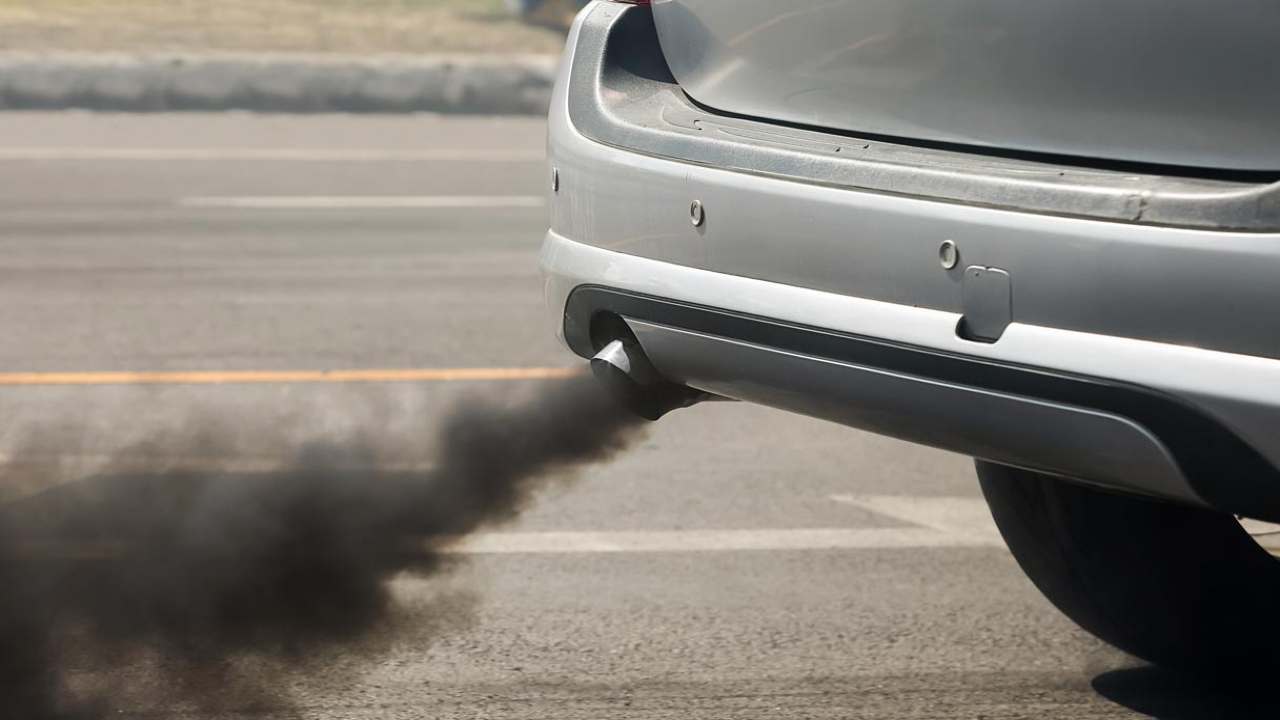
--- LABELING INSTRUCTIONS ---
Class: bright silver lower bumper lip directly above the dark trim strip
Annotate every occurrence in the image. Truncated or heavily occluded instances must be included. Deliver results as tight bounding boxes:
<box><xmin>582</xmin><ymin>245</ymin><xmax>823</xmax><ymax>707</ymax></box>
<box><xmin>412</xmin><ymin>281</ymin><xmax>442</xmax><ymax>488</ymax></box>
<box><xmin>540</xmin><ymin>232</ymin><xmax>1280</xmax><ymax>476</ymax></box>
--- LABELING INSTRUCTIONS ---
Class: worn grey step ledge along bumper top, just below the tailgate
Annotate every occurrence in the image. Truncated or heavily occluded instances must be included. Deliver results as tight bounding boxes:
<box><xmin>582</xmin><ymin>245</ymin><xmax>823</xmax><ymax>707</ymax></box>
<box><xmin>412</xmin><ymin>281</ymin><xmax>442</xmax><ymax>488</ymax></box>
<box><xmin>562</xmin><ymin>3</ymin><xmax>1280</xmax><ymax>232</ymax></box>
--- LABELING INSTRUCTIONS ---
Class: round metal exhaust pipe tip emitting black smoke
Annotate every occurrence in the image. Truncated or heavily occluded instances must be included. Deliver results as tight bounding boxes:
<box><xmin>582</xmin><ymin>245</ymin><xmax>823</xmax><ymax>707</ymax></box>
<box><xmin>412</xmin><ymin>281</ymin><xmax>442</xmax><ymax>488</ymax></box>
<box><xmin>591</xmin><ymin>340</ymin><xmax>713</xmax><ymax>420</ymax></box>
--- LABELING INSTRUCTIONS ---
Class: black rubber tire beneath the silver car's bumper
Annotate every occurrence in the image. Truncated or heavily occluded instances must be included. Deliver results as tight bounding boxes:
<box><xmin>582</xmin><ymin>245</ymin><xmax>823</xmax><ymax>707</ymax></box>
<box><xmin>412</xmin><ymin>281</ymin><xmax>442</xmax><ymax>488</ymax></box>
<box><xmin>977</xmin><ymin>460</ymin><xmax>1280</xmax><ymax>676</ymax></box>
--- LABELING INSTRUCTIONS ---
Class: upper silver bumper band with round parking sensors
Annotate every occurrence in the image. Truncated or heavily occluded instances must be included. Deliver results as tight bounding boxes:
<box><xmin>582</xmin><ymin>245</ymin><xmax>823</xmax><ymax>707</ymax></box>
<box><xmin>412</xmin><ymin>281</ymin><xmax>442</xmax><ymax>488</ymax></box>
<box><xmin>548</xmin><ymin>5</ymin><xmax>1280</xmax><ymax>357</ymax></box>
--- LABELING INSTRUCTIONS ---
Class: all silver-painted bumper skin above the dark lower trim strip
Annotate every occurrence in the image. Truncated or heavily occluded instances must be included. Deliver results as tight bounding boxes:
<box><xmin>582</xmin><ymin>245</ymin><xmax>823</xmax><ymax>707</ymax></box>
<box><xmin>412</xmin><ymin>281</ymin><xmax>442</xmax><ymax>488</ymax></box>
<box><xmin>541</xmin><ymin>6</ymin><xmax>1280</xmax><ymax>497</ymax></box>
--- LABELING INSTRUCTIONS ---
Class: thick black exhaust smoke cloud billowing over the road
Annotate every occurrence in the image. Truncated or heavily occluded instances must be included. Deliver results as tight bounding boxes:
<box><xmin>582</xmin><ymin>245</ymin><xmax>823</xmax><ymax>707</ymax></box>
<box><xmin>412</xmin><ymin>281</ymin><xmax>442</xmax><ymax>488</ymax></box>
<box><xmin>0</xmin><ymin>377</ymin><xmax>639</xmax><ymax>720</ymax></box>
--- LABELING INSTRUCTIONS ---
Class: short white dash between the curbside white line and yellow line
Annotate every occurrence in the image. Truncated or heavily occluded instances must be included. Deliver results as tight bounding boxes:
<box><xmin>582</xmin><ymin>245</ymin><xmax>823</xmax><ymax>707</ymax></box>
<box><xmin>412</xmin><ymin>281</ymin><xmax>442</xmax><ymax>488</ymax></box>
<box><xmin>178</xmin><ymin>195</ymin><xmax>547</xmax><ymax>210</ymax></box>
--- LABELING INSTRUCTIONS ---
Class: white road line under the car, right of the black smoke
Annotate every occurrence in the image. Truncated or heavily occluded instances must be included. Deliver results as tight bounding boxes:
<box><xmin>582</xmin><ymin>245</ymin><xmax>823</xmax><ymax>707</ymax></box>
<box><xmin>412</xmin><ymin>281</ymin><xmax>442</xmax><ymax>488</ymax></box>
<box><xmin>440</xmin><ymin>528</ymin><xmax>988</xmax><ymax>555</ymax></box>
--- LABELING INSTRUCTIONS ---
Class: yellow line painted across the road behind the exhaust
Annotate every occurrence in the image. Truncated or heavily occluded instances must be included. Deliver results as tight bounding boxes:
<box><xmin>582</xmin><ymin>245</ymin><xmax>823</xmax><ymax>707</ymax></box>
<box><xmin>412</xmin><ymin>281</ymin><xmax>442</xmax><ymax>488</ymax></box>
<box><xmin>0</xmin><ymin>368</ymin><xmax>582</xmax><ymax>386</ymax></box>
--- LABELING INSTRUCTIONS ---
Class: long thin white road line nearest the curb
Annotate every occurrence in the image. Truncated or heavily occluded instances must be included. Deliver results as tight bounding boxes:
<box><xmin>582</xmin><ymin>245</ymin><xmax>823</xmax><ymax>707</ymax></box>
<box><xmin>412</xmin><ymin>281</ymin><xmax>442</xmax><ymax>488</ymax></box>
<box><xmin>0</xmin><ymin>147</ymin><xmax>545</xmax><ymax>163</ymax></box>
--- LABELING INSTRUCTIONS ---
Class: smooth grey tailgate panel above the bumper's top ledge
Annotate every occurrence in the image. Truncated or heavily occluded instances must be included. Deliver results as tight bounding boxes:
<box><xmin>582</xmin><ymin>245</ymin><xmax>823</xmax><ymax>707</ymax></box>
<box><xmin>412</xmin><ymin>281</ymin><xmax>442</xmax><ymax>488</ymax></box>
<box><xmin>653</xmin><ymin>0</ymin><xmax>1280</xmax><ymax>172</ymax></box>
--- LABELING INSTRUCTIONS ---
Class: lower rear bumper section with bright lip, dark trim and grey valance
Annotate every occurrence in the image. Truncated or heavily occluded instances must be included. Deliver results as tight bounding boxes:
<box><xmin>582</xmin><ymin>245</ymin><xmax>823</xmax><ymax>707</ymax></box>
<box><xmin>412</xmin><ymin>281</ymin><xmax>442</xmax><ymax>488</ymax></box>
<box><xmin>541</xmin><ymin>232</ymin><xmax>1280</xmax><ymax>519</ymax></box>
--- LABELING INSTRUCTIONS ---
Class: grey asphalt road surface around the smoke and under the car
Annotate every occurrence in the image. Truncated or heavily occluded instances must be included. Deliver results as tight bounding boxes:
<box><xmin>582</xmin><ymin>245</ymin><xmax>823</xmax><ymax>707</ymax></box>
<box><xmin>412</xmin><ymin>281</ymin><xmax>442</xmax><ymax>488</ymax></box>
<box><xmin>0</xmin><ymin>114</ymin><xmax>1225</xmax><ymax>719</ymax></box>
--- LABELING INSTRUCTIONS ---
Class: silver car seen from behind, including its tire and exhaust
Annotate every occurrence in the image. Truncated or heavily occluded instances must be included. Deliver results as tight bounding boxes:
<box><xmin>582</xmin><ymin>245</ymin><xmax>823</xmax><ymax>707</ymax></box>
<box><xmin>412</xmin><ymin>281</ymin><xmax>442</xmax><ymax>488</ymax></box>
<box><xmin>541</xmin><ymin>0</ymin><xmax>1280</xmax><ymax>669</ymax></box>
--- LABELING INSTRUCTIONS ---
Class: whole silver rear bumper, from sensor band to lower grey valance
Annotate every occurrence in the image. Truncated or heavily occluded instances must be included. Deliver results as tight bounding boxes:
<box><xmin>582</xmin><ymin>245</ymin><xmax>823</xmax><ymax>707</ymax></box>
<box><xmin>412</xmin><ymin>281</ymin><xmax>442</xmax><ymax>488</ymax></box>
<box><xmin>541</xmin><ymin>1</ymin><xmax>1280</xmax><ymax>518</ymax></box>
